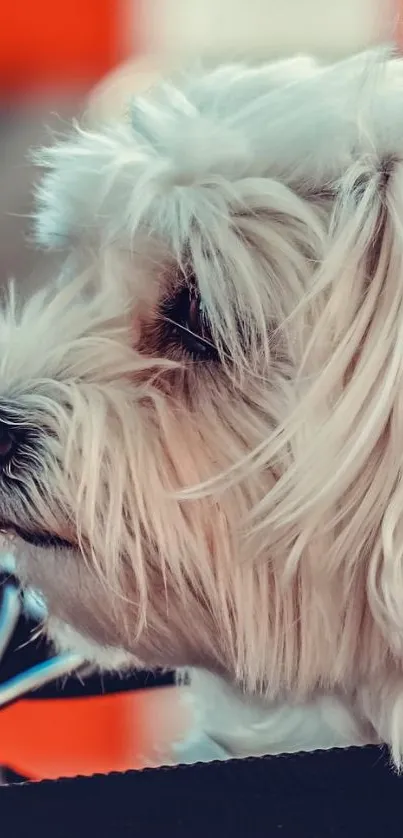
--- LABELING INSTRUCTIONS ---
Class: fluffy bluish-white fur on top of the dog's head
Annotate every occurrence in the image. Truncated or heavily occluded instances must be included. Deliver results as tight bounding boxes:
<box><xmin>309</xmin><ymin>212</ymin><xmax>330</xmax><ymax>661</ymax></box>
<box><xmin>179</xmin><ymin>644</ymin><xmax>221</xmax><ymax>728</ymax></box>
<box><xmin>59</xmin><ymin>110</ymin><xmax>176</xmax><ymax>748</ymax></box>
<box><xmin>35</xmin><ymin>51</ymin><xmax>403</xmax><ymax>251</ymax></box>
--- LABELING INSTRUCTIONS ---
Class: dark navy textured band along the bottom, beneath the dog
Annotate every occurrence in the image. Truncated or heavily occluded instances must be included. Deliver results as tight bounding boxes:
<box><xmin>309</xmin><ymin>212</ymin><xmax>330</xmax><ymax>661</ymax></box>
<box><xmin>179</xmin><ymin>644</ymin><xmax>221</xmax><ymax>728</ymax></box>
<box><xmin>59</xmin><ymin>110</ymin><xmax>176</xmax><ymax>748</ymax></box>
<box><xmin>0</xmin><ymin>747</ymin><xmax>403</xmax><ymax>838</ymax></box>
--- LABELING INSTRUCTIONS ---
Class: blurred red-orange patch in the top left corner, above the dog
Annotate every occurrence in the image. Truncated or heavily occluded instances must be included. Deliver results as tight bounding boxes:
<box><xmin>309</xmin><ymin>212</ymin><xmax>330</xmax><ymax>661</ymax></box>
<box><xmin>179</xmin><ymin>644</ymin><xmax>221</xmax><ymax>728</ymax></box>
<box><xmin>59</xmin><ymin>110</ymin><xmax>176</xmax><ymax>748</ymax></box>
<box><xmin>0</xmin><ymin>0</ymin><xmax>137</xmax><ymax>95</ymax></box>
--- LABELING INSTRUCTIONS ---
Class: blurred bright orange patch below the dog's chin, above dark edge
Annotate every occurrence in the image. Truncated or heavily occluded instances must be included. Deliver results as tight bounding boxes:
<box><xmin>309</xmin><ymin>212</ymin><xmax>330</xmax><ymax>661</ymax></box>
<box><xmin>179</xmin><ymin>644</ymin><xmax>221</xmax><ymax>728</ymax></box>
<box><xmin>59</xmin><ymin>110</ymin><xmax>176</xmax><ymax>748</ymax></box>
<box><xmin>0</xmin><ymin>687</ymin><xmax>185</xmax><ymax>782</ymax></box>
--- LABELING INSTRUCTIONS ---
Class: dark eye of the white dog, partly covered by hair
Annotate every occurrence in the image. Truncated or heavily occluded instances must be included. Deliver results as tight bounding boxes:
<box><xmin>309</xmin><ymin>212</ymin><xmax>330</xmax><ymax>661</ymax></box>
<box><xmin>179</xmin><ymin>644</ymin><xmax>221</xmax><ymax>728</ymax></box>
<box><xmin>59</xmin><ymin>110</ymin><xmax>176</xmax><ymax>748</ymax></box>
<box><xmin>163</xmin><ymin>285</ymin><xmax>218</xmax><ymax>361</ymax></box>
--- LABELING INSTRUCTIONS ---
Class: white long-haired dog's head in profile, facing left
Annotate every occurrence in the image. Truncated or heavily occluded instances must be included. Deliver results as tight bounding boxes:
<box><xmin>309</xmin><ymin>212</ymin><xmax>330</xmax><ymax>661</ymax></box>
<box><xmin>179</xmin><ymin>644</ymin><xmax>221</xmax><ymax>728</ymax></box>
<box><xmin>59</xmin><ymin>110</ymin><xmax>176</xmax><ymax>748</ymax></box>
<box><xmin>0</xmin><ymin>47</ymin><xmax>403</xmax><ymax>765</ymax></box>
